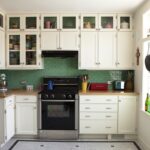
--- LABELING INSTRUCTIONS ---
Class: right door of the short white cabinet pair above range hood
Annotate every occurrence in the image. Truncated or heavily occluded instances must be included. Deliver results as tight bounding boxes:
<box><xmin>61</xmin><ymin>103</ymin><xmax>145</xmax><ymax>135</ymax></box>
<box><xmin>60</xmin><ymin>32</ymin><xmax>79</xmax><ymax>50</ymax></box>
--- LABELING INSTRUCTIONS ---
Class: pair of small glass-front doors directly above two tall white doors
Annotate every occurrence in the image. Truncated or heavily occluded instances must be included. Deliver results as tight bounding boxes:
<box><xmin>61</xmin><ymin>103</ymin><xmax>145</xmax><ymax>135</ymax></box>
<box><xmin>81</xmin><ymin>14</ymin><xmax>116</xmax><ymax>31</ymax></box>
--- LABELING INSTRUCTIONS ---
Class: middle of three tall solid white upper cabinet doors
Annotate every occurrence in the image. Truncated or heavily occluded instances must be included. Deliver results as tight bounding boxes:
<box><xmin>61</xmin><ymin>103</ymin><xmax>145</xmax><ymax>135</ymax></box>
<box><xmin>99</xmin><ymin>32</ymin><xmax>116</xmax><ymax>69</ymax></box>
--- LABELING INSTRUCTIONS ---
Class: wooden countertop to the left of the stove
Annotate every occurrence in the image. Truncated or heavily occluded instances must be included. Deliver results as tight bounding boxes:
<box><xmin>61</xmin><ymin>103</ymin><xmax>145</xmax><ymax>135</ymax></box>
<box><xmin>0</xmin><ymin>89</ymin><xmax>38</xmax><ymax>99</ymax></box>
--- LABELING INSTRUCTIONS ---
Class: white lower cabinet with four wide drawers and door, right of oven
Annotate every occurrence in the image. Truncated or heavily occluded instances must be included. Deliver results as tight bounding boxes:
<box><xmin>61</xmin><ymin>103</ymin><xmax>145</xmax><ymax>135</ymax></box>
<box><xmin>79</xmin><ymin>95</ymin><xmax>137</xmax><ymax>134</ymax></box>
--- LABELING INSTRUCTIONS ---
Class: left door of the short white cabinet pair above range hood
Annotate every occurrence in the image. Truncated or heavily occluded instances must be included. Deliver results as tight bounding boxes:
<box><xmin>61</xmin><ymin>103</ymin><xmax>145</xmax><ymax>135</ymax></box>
<box><xmin>41</xmin><ymin>32</ymin><xmax>59</xmax><ymax>50</ymax></box>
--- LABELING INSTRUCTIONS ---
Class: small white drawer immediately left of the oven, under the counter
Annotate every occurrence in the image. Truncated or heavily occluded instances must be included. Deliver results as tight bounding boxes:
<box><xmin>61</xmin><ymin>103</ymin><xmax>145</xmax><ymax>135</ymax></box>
<box><xmin>16</xmin><ymin>95</ymin><xmax>37</xmax><ymax>103</ymax></box>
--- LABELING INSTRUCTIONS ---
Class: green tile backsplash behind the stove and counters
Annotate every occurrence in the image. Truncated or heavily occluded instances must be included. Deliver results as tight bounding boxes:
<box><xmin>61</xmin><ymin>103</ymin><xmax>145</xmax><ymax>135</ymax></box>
<box><xmin>0</xmin><ymin>57</ymin><xmax>133</xmax><ymax>89</ymax></box>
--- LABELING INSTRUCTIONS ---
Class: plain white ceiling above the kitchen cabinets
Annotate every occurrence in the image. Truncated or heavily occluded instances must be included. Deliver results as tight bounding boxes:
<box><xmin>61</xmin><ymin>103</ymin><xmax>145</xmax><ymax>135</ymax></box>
<box><xmin>0</xmin><ymin>0</ymin><xmax>146</xmax><ymax>12</ymax></box>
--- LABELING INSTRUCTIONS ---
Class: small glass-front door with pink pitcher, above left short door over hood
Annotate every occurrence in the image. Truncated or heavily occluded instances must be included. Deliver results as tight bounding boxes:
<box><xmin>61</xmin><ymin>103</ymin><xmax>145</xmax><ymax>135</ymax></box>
<box><xmin>41</xmin><ymin>14</ymin><xmax>59</xmax><ymax>31</ymax></box>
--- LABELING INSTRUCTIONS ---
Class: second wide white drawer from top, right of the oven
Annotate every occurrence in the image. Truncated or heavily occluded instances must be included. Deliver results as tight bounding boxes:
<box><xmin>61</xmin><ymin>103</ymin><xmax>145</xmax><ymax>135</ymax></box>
<box><xmin>80</xmin><ymin>104</ymin><xmax>117</xmax><ymax>112</ymax></box>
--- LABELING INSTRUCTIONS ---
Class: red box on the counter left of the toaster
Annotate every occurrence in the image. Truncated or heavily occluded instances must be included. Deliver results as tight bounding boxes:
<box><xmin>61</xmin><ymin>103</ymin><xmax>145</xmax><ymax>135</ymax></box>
<box><xmin>90</xmin><ymin>83</ymin><xmax>108</xmax><ymax>91</ymax></box>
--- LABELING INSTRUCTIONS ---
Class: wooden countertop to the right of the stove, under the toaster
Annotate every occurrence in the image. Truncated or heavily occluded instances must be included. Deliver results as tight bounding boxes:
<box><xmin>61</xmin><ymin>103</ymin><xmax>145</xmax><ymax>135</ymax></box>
<box><xmin>79</xmin><ymin>91</ymin><xmax>139</xmax><ymax>96</ymax></box>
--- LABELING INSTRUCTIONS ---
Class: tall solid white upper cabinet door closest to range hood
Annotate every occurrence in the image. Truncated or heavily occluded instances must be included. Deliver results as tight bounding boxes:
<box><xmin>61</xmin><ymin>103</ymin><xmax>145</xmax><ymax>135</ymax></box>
<box><xmin>80</xmin><ymin>32</ymin><xmax>98</xmax><ymax>69</ymax></box>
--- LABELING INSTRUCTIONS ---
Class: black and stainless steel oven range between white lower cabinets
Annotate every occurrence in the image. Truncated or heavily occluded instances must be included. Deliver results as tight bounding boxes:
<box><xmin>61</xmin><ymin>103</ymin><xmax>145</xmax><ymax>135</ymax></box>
<box><xmin>38</xmin><ymin>78</ymin><xmax>79</xmax><ymax>139</ymax></box>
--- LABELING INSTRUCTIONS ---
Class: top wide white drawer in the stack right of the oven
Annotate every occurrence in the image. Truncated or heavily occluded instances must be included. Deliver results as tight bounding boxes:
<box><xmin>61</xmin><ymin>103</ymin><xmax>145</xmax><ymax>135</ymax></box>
<box><xmin>80</xmin><ymin>95</ymin><xmax>118</xmax><ymax>104</ymax></box>
